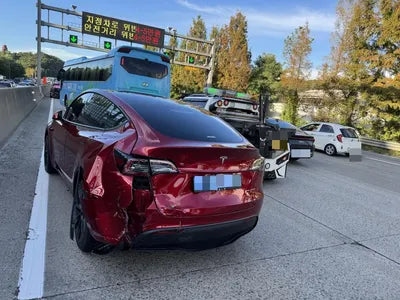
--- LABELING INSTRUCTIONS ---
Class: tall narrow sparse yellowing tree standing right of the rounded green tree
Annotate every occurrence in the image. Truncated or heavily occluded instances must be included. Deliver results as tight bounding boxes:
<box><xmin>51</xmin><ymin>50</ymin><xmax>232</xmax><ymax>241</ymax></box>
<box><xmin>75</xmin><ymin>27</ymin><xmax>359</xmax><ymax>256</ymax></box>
<box><xmin>282</xmin><ymin>23</ymin><xmax>313</xmax><ymax>124</ymax></box>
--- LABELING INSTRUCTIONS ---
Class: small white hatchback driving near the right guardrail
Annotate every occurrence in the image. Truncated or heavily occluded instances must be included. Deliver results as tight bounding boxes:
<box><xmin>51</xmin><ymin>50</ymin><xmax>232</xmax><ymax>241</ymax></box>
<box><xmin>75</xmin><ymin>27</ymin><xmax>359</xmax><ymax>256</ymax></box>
<box><xmin>301</xmin><ymin>122</ymin><xmax>361</xmax><ymax>155</ymax></box>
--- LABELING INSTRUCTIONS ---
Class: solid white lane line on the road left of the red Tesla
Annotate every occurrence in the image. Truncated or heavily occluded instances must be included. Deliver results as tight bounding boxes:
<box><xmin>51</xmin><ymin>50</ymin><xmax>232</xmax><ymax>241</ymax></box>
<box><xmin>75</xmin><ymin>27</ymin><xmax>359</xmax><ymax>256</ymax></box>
<box><xmin>18</xmin><ymin>100</ymin><xmax>53</xmax><ymax>299</ymax></box>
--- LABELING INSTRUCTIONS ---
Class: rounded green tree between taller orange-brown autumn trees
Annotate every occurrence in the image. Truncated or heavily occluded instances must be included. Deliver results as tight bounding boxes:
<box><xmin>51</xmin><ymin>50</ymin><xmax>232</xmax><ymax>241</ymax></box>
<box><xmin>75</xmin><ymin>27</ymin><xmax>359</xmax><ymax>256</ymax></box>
<box><xmin>249</xmin><ymin>53</ymin><xmax>282</xmax><ymax>101</ymax></box>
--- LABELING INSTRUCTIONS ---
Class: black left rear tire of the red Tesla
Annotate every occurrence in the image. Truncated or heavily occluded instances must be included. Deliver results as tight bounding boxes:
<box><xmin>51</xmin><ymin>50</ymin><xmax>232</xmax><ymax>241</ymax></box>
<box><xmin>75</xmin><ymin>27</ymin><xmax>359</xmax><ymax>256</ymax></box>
<box><xmin>71</xmin><ymin>175</ymin><xmax>112</xmax><ymax>254</ymax></box>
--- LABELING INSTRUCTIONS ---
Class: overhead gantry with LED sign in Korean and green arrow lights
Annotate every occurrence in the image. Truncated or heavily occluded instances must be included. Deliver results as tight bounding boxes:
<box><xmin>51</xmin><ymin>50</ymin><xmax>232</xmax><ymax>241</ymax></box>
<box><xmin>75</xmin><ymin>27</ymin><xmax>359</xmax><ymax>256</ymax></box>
<box><xmin>36</xmin><ymin>0</ymin><xmax>215</xmax><ymax>86</ymax></box>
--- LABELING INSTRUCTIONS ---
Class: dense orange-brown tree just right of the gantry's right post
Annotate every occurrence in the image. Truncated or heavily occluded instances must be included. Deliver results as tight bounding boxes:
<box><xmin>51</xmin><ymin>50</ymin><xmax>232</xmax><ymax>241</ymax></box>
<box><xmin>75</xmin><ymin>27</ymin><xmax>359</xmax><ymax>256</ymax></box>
<box><xmin>216</xmin><ymin>12</ymin><xmax>250</xmax><ymax>91</ymax></box>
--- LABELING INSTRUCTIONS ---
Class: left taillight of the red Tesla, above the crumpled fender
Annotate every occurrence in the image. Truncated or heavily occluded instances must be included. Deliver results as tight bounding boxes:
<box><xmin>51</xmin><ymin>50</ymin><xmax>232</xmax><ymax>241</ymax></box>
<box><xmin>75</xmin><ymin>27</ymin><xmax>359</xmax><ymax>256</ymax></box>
<box><xmin>114</xmin><ymin>150</ymin><xmax>178</xmax><ymax>176</ymax></box>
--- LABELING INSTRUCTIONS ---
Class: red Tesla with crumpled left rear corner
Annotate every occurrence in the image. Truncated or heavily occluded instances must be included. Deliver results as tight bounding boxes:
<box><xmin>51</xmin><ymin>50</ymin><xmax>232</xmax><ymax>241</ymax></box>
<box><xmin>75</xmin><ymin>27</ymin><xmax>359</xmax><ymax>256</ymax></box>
<box><xmin>45</xmin><ymin>90</ymin><xmax>263</xmax><ymax>249</ymax></box>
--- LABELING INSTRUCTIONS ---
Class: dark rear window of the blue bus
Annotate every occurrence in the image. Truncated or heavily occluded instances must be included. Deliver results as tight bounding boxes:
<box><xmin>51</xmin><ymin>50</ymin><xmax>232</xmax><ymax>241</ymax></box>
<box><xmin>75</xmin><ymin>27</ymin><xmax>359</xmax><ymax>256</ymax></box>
<box><xmin>121</xmin><ymin>56</ymin><xmax>168</xmax><ymax>79</ymax></box>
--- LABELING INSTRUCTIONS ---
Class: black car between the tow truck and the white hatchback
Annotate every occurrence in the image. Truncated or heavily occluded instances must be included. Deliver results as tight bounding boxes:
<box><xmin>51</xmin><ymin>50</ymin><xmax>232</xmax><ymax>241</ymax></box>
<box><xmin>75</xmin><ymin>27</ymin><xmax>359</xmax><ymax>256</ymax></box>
<box><xmin>265</xmin><ymin>118</ymin><xmax>315</xmax><ymax>160</ymax></box>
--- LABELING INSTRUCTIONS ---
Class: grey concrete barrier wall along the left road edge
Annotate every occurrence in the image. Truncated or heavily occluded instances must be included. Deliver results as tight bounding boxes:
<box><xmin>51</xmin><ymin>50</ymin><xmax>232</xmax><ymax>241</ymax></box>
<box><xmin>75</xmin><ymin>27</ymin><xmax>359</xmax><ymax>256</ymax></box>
<box><xmin>0</xmin><ymin>86</ymin><xmax>50</xmax><ymax>147</ymax></box>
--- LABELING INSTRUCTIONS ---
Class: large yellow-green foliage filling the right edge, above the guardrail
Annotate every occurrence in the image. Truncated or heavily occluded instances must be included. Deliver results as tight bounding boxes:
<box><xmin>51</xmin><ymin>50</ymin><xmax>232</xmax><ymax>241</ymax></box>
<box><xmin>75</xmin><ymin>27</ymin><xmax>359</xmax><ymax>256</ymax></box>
<box><xmin>321</xmin><ymin>0</ymin><xmax>400</xmax><ymax>140</ymax></box>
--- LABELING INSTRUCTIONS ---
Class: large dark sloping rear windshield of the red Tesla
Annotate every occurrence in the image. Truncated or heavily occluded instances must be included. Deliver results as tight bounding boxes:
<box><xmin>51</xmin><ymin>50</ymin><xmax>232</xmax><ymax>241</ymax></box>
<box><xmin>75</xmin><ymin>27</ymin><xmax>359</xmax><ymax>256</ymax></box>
<box><xmin>122</xmin><ymin>93</ymin><xmax>243</xmax><ymax>143</ymax></box>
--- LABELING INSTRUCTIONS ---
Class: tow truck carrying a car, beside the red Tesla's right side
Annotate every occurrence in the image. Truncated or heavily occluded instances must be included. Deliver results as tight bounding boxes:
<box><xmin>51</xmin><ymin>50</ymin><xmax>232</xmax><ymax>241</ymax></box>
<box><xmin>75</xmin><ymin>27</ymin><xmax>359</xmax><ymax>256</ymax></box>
<box><xmin>182</xmin><ymin>87</ymin><xmax>294</xmax><ymax>180</ymax></box>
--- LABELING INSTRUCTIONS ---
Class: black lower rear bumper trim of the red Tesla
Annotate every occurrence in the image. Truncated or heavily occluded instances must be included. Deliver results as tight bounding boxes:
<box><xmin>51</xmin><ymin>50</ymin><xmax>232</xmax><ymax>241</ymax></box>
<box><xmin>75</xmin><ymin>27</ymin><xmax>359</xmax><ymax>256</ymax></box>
<box><xmin>132</xmin><ymin>216</ymin><xmax>258</xmax><ymax>250</ymax></box>
